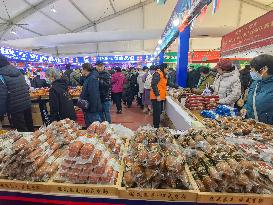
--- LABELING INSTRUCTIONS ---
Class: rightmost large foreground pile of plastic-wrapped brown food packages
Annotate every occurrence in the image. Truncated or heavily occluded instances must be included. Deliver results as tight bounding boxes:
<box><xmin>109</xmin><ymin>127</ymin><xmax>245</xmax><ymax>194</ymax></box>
<box><xmin>177</xmin><ymin>128</ymin><xmax>273</xmax><ymax>194</ymax></box>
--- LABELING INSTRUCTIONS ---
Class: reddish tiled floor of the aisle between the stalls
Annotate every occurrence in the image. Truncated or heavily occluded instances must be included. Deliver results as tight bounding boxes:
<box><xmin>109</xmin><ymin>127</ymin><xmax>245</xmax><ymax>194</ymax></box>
<box><xmin>111</xmin><ymin>101</ymin><xmax>152</xmax><ymax>131</ymax></box>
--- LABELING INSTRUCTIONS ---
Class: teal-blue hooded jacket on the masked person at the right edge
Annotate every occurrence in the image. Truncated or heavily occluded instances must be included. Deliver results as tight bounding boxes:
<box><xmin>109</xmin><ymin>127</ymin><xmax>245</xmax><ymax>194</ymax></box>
<box><xmin>244</xmin><ymin>76</ymin><xmax>273</xmax><ymax>125</ymax></box>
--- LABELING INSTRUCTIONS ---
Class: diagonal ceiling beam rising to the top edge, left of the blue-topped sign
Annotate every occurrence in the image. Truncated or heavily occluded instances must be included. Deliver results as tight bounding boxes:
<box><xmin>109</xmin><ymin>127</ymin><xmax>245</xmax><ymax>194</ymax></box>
<box><xmin>73</xmin><ymin>0</ymin><xmax>154</xmax><ymax>33</ymax></box>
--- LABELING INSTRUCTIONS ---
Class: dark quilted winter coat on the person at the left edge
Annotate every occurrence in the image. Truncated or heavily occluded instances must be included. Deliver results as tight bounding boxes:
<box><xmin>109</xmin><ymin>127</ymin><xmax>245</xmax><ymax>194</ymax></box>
<box><xmin>0</xmin><ymin>65</ymin><xmax>31</xmax><ymax>114</ymax></box>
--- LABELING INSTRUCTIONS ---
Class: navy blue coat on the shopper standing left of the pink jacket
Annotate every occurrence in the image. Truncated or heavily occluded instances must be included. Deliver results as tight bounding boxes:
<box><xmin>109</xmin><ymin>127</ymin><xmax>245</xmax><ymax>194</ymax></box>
<box><xmin>80</xmin><ymin>70</ymin><xmax>102</xmax><ymax>113</ymax></box>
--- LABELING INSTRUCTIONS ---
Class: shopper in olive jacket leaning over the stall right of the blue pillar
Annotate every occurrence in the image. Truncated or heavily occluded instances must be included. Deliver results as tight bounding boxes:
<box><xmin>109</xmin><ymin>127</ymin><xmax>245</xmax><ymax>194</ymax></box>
<box><xmin>193</xmin><ymin>66</ymin><xmax>214</xmax><ymax>95</ymax></box>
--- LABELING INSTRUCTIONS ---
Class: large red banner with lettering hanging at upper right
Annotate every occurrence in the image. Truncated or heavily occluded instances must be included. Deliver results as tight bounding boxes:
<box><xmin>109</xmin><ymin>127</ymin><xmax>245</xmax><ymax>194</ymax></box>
<box><xmin>221</xmin><ymin>10</ymin><xmax>273</xmax><ymax>56</ymax></box>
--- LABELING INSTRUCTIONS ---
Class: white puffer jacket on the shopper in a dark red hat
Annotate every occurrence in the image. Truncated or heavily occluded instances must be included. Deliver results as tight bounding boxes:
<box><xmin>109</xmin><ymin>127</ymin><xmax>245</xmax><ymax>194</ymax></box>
<box><xmin>212</xmin><ymin>69</ymin><xmax>242</xmax><ymax>107</ymax></box>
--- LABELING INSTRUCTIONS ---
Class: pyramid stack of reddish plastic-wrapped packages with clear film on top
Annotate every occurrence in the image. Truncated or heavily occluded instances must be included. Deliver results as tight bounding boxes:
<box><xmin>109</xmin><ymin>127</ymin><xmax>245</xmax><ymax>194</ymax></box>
<box><xmin>58</xmin><ymin>136</ymin><xmax>120</xmax><ymax>184</ymax></box>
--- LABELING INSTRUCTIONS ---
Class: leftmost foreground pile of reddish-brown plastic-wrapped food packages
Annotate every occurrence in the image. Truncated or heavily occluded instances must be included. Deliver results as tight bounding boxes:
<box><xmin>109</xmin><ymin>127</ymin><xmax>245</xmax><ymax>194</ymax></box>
<box><xmin>0</xmin><ymin>119</ymin><xmax>80</xmax><ymax>181</ymax></box>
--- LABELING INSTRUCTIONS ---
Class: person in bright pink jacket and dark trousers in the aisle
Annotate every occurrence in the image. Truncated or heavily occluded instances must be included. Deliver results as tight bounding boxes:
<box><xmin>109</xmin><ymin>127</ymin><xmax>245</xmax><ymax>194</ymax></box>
<box><xmin>112</xmin><ymin>67</ymin><xmax>126</xmax><ymax>114</ymax></box>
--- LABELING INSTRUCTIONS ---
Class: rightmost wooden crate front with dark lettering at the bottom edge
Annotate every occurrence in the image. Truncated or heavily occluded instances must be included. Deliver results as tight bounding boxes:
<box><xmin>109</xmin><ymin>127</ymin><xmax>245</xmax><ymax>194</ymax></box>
<box><xmin>197</xmin><ymin>192</ymin><xmax>273</xmax><ymax>205</ymax></box>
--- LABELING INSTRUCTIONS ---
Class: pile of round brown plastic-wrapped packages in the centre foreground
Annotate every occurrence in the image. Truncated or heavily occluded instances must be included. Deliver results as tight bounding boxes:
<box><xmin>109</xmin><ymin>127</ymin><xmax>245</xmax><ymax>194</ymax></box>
<box><xmin>123</xmin><ymin>127</ymin><xmax>192</xmax><ymax>189</ymax></box>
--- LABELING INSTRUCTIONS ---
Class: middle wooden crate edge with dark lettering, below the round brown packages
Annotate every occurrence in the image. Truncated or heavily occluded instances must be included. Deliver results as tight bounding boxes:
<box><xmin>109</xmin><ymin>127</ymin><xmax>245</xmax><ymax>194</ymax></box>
<box><xmin>118</xmin><ymin>165</ymin><xmax>198</xmax><ymax>202</ymax></box>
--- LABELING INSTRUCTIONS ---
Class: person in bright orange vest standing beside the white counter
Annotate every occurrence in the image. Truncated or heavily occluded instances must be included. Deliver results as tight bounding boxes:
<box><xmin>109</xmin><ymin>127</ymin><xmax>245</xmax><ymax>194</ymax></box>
<box><xmin>150</xmin><ymin>64</ymin><xmax>168</xmax><ymax>128</ymax></box>
